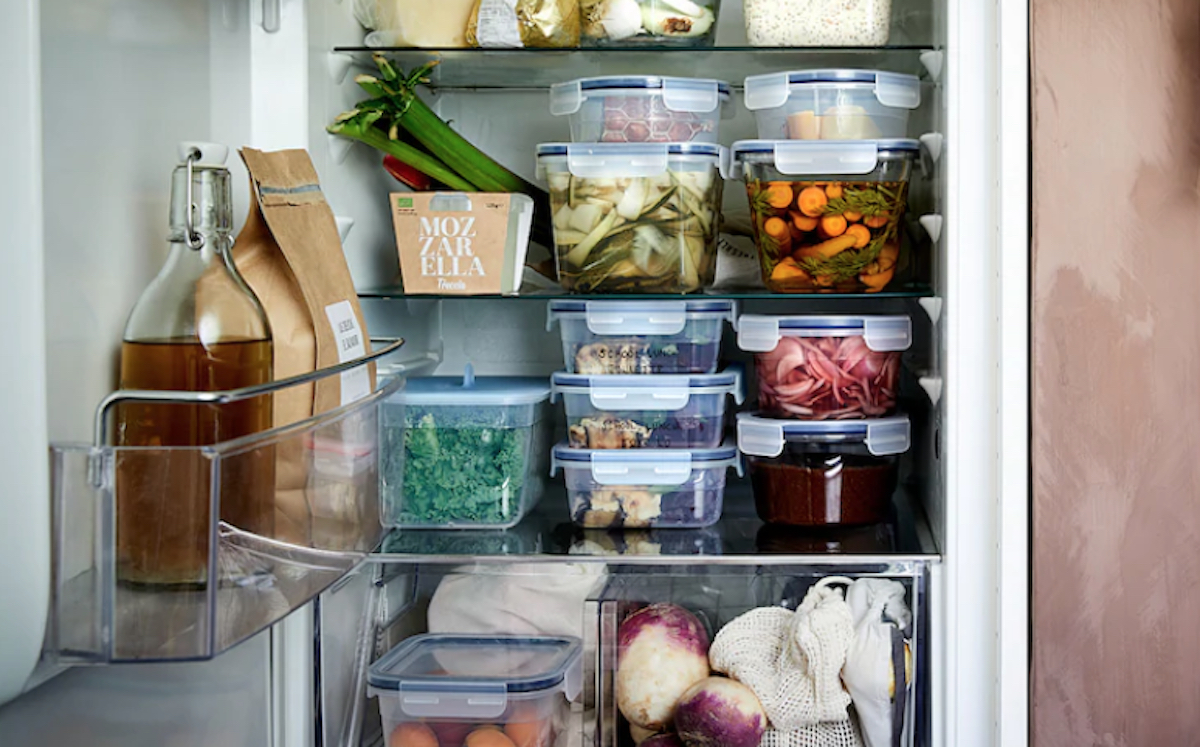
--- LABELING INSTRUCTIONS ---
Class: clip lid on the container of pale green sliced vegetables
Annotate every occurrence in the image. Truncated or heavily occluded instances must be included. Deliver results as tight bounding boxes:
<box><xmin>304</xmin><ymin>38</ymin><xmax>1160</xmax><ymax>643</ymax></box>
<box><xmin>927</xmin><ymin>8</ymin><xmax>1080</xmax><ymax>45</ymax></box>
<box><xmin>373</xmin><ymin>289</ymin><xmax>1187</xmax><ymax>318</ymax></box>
<box><xmin>538</xmin><ymin>143</ymin><xmax>730</xmax><ymax>179</ymax></box>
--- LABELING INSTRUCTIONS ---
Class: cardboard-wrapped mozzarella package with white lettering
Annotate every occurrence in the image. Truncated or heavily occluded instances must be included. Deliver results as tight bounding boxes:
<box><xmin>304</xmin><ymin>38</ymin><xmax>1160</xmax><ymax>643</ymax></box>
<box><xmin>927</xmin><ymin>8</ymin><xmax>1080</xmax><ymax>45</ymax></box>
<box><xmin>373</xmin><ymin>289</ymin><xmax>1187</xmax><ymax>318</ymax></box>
<box><xmin>391</xmin><ymin>192</ymin><xmax>524</xmax><ymax>295</ymax></box>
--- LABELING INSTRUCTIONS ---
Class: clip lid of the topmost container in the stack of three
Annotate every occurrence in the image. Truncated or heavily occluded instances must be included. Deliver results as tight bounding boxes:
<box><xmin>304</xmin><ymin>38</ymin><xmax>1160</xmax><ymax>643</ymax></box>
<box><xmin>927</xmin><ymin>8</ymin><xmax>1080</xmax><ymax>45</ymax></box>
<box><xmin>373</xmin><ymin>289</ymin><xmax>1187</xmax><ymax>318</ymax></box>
<box><xmin>546</xmin><ymin>299</ymin><xmax>737</xmax><ymax>335</ymax></box>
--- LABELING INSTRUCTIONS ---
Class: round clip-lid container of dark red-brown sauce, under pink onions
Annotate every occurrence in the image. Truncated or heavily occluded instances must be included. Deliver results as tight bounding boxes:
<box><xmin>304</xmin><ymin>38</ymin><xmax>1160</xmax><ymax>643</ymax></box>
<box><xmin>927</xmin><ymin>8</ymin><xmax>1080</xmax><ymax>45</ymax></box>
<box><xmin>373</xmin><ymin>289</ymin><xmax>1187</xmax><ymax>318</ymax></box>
<box><xmin>738</xmin><ymin>413</ymin><xmax>910</xmax><ymax>526</ymax></box>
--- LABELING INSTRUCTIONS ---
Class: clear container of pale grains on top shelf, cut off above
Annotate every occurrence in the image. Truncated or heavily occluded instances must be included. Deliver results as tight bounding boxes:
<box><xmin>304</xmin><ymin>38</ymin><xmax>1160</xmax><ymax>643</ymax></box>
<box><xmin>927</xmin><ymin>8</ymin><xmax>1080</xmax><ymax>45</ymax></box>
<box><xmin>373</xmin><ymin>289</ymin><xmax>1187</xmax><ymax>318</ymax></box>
<box><xmin>743</xmin><ymin>0</ymin><xmax>892</xmax><ymax>47</ymax></box>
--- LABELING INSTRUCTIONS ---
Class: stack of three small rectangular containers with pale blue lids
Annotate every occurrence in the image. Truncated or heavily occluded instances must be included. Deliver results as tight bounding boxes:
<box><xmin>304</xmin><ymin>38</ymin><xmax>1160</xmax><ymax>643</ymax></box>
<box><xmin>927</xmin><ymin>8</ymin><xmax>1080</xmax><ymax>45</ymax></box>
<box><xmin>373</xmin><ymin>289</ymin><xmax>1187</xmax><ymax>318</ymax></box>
<box><xmin>548</xmin><ymin>299</ymin><xmax>743</xmax><ymax>528</ymax></box>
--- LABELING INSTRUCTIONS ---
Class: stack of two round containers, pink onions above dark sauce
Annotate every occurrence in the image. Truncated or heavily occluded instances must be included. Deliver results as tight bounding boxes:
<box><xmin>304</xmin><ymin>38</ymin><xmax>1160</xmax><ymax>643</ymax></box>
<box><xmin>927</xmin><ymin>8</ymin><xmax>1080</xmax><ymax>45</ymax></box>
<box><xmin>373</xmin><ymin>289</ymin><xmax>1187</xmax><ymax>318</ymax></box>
<box><xmin>737</xmin><ymin>315</ymin><xmax>912</xmax><ymax>526</ymax></box>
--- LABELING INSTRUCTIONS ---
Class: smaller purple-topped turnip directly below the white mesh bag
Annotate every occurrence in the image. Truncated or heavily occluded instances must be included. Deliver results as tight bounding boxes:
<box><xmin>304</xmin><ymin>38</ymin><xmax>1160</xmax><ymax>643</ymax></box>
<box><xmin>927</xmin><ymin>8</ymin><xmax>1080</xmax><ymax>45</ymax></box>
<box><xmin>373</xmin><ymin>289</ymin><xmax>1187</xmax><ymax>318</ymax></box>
<box><xmin>674</xmin><ymin>677</ymin><xmax>767</xmax><ymax>747</ymax></box>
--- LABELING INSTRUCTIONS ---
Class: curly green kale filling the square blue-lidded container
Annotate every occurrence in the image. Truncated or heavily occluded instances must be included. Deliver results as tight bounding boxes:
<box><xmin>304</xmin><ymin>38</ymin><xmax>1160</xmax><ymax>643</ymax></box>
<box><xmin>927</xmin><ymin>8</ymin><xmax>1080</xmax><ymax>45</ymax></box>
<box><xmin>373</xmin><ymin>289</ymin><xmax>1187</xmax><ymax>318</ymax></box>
<box><xmin>401</xmin><ymin>414</ymin><xmax>529</xmax><ymax>525</ymax></box>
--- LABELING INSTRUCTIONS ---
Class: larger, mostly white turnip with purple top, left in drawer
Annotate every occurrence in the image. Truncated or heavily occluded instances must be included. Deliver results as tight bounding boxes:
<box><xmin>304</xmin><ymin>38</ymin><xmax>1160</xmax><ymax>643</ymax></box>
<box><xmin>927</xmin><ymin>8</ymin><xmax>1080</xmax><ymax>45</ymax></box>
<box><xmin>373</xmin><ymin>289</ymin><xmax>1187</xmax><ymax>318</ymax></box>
<box><xmin>617</xmin><ymin>604</ymin><xmax>709</xmax><ymax>731</ymax></box>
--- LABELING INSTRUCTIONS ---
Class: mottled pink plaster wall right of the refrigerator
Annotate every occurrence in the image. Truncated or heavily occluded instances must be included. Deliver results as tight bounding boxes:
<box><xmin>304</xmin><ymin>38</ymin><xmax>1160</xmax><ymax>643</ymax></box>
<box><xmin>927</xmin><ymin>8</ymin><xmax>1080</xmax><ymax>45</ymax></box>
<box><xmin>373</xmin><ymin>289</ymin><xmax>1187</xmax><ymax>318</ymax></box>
<box><xmin>1032</xmin><ymin>0</ymin><xmax>1200</xmax><ymax>747</ymax></box>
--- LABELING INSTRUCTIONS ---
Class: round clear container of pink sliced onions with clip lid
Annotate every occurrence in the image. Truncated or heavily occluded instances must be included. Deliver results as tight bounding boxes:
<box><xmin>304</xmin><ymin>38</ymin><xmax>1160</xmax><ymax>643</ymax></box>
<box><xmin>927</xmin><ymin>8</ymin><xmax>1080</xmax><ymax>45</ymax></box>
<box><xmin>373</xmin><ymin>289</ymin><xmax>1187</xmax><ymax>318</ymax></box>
<box><xmin>738</xmin><ymin>313</ymin><xmax>912</xmax><ymax>420</ymax></box>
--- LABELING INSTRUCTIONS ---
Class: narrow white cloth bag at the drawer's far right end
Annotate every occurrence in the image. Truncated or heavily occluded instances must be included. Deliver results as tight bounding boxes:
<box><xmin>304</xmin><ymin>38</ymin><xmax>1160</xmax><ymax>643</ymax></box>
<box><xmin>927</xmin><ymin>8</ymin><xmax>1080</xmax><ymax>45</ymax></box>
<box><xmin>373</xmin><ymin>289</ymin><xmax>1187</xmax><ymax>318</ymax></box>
<box><xmin>842</xmin><ymin>579</ymin><xmax>912</xmax><ymax>747</ymax></box>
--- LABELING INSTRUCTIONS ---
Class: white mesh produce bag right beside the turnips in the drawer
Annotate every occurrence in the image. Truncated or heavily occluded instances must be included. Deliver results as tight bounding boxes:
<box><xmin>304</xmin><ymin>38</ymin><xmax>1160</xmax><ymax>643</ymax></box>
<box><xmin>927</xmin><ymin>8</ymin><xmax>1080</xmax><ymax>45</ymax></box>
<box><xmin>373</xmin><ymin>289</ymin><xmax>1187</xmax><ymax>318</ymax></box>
<box><xmin>708</xmin><ymin>576</ymin><xmax>854</xmax><ymax>730</ymax></box>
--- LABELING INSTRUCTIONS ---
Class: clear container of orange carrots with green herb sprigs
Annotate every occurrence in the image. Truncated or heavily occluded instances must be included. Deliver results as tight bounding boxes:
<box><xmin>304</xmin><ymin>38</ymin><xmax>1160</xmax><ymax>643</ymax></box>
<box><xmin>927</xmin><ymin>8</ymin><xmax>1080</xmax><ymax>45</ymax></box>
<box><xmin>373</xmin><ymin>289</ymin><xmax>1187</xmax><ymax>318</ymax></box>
<box><xmin>740</xmin><ymin>141</ymin><xmax>914</xmax><ymax>293</ymax></box>
